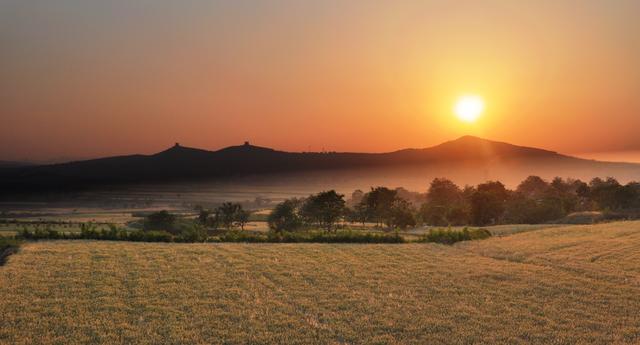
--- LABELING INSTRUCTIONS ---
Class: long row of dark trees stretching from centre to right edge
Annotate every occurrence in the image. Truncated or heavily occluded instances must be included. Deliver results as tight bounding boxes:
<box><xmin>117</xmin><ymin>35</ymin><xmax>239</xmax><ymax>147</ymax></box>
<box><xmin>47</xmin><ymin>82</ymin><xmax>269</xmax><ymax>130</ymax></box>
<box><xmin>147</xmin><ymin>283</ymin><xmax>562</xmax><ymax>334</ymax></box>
<box><xmin>268</xmin><ymin>176</ymin><xmax>640</xmax><ymax>231</ymax></box>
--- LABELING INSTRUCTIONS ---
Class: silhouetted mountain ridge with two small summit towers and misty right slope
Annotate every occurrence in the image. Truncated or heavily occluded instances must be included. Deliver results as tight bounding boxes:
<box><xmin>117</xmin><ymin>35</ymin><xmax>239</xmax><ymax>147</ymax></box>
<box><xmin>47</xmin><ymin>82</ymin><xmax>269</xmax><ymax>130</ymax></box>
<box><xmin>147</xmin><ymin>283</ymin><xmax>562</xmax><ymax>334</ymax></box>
<box><xmin>0</xmin><ymin>136</ymin><xmax>640</xmax><ymax>192</ymax></box>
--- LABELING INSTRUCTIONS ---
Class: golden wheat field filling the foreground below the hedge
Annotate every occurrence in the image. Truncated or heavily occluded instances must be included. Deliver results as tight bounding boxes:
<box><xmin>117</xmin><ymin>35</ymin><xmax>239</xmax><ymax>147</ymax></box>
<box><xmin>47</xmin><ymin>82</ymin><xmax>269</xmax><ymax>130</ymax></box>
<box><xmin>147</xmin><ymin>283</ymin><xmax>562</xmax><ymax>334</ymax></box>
<box><xmin>0</xmin><ymin>222</ymin><xmax>640</xmax><ymax>344</ymax></box>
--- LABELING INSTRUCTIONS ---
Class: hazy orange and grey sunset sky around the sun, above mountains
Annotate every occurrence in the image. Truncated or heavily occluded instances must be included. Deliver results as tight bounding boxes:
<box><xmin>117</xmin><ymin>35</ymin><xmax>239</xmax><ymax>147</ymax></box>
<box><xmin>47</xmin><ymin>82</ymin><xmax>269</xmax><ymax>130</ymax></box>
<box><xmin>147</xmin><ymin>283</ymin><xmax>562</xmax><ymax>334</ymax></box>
<box><xmin>0</xmin><ymin>0</ymin><xmax>640</xmax><ymax>161</ymax></box>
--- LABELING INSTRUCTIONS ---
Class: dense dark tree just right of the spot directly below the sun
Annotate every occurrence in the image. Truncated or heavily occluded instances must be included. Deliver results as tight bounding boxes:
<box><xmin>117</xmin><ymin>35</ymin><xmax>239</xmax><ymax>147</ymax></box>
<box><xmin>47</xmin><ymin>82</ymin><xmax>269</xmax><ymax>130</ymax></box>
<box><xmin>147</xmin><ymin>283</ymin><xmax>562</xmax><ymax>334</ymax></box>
<box><xmin>471</xmin><ymin>181</ymin><xmax>509</xmax><ymax>225</ymax></box>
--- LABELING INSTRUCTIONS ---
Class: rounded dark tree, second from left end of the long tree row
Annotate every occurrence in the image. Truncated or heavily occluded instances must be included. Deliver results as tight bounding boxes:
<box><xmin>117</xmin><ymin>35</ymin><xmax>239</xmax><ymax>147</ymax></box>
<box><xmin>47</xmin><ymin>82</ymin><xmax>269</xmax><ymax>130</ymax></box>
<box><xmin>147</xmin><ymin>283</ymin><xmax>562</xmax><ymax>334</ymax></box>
<box><xmin>301</xmin><ymin>190</ymin><xmax>345</xmax><ymax>231</ymax></box>
